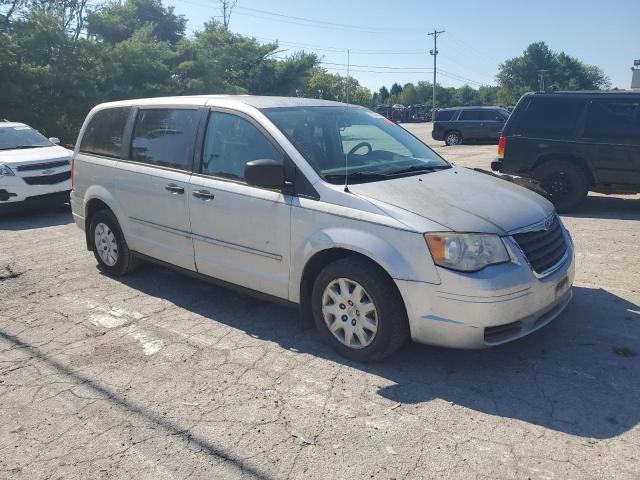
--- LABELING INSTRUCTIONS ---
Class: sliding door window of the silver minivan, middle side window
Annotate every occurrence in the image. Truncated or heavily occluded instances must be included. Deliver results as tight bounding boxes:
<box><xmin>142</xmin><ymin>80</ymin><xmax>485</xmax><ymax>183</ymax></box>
<box><xmin>131</xmin><ymin>109</ymin><xmax>200</xmax><ymax>170</ymax></box>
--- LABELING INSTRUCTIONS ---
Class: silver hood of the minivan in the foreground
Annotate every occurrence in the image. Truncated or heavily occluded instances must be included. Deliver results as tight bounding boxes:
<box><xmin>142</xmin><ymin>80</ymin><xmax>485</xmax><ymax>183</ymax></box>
<box><xmin>349</xmin><ymin>167</ymin><xmax>553</xmax><ymax>235</ymax></box>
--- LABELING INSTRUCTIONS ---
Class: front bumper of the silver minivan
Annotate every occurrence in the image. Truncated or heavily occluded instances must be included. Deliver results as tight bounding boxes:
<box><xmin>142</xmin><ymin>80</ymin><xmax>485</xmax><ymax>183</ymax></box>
<box><xmin>395</xmin><ymin>227</ymin><xmax>575</xmax><ymax>348</ymax></box>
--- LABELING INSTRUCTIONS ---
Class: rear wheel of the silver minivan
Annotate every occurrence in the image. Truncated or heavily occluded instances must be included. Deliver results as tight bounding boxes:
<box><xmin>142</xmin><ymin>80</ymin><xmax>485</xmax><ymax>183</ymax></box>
<box><xmin>89</xmin><ymin>210</ymin><xmax>138</xmax><ymax>276</ymax></box>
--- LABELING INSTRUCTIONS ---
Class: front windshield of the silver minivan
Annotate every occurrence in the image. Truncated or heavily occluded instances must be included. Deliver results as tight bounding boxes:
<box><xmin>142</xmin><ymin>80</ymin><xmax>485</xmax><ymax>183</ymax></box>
<box><xmin>263</xmin><ymin>106</ymin><xmax>451</xmax><ymax>184</ymax></box>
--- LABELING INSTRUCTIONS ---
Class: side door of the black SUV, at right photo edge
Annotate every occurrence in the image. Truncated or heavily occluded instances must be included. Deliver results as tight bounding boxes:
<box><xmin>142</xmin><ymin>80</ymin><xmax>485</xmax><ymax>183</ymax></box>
<box><xmin>582</xmin><ymin>95</ymin><xmax>640</xmax><ymax>185</ymax></box>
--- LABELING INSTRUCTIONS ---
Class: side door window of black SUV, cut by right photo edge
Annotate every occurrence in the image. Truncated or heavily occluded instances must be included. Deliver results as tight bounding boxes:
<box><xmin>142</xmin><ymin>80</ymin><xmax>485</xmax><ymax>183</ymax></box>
<box><xmin>584</xmin><ymin>100</ymin><xmax>640</xmax><ymax>141</ymax></box>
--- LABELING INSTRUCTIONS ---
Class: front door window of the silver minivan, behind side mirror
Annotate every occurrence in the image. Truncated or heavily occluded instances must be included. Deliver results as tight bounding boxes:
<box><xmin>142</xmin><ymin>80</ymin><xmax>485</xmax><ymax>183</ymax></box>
<box><xmin>202</xmin><ymin>112</ymin><xmax>283</xmax><ymax>180</ymax></box>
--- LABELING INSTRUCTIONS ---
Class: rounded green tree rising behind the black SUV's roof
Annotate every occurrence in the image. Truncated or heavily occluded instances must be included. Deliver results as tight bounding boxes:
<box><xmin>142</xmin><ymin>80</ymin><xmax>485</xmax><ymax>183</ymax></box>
<box><xmin>497</xmin><ymin>42</ymin><xmax>610</xmax><ymax>104</ymax></box>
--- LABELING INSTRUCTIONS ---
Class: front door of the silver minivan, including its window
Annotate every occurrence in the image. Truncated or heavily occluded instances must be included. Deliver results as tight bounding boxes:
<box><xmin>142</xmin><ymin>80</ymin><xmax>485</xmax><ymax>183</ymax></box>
<box><xmin>187</xmin><ymin>109</ymin><xmax>291</xmax><ymax>299</ymax></box>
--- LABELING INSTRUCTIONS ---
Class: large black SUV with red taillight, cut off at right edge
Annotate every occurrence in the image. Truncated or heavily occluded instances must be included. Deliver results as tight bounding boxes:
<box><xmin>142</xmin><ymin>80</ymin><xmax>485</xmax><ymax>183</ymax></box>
<box><xmin>491</xmin><ymin>92</ymin><xmax>640</xmax><ymax>212</ymax></box>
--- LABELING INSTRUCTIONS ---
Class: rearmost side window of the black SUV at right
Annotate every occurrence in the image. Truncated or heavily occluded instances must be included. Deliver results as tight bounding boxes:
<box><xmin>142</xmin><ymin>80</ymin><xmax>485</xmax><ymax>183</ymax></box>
<box><xmin>514</xmin><ymin>97</ymin><xmax>585</xmax><ymax>136</ymax></box>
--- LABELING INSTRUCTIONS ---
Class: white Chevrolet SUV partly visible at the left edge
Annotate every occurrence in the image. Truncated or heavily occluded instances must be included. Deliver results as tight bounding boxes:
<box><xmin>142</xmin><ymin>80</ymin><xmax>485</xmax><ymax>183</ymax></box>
<box><xmin>0</xmin><ymin>121</ymin><xmax>72</xmax><ymax>210</ymax></box>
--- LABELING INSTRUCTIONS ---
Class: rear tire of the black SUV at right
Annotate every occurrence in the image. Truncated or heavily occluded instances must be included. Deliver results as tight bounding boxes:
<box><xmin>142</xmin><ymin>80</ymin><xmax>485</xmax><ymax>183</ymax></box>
<box><xmin>533</xmin><ymin>160</ymin><xmax>589</xmax><ymax>213</ymax></box>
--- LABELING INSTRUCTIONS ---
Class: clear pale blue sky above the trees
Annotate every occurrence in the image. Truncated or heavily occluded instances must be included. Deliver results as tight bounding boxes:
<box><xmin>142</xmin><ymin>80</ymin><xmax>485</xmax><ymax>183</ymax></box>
<box><xmin>170</xmin><ymin>0</ymin><xmax>640</xmax><ymax>90</ymax></box>
